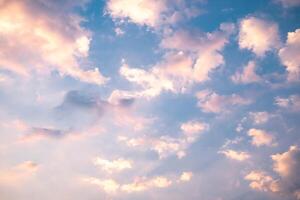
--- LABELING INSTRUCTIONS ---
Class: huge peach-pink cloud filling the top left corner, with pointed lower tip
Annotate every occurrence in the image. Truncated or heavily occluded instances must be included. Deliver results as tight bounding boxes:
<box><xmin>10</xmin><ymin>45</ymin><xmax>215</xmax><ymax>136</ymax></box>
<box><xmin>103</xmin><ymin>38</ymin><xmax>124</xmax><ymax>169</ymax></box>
<box><xmin>0</xmin><ymin>0</ymin><xmax>108</xmax><ymax>84</ymax></box>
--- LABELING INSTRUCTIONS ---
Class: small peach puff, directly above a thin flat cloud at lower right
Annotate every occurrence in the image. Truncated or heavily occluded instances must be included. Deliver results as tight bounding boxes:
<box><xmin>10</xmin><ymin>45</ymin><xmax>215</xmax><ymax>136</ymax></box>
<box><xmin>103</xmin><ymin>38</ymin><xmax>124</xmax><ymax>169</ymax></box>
<box><xmin>248</xmin><ymin>128</ymin><xmax>275</xmax><ymax>147</ymax></box>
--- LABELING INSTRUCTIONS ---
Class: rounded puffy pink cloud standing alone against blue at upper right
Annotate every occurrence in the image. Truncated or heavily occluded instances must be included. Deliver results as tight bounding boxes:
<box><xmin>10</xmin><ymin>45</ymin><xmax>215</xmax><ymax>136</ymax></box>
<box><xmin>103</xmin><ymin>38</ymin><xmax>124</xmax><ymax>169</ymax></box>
<box><xmin>239</xmin><ymin>16</ymin><xmax>280</xmax><ymax>56</ymax></box>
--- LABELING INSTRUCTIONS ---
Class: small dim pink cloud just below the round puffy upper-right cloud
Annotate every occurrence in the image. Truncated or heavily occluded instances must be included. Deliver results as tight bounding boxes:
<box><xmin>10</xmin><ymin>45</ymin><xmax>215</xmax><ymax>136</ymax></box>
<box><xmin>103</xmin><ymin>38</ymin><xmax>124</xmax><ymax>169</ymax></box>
<box><xmin>231</xmin><ymin>61</ymin><xmax>262</xmax><ymax>84</ymax></box>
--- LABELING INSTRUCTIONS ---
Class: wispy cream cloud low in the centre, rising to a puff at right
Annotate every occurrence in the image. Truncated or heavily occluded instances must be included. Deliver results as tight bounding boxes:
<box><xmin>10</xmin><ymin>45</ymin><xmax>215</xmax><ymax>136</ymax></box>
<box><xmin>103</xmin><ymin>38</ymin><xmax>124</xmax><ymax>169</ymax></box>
<box><xmin>119</xmin><ymin>121</ymin><xmax>209</xmax><ymax>159</ymax></box>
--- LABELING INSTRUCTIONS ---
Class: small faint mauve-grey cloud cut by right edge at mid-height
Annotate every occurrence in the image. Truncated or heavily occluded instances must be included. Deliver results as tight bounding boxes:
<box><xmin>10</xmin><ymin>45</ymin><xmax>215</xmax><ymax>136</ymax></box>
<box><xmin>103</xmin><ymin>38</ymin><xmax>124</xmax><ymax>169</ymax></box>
<box><xmin>275</xmin><ymin>95</ymin><xmax>300</xmax><ymax>112</ymax></box>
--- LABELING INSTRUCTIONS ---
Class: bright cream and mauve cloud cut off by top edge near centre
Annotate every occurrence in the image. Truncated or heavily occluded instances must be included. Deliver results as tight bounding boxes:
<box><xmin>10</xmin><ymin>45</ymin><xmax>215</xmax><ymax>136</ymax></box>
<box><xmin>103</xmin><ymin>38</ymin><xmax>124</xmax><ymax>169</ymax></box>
<box><xmin>105</xmin><ymin>0</ymin><xmax>201</xmax><ymax>28</ymax></box>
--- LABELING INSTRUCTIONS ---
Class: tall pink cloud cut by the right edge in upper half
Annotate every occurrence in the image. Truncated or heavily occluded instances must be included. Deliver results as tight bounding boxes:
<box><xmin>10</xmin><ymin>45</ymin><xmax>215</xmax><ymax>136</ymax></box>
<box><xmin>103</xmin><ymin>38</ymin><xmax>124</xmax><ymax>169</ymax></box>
<box><xmin>278</xmin><ymin>29</ymin><xmax>300</xmax><ymax>81</ymax></box>
